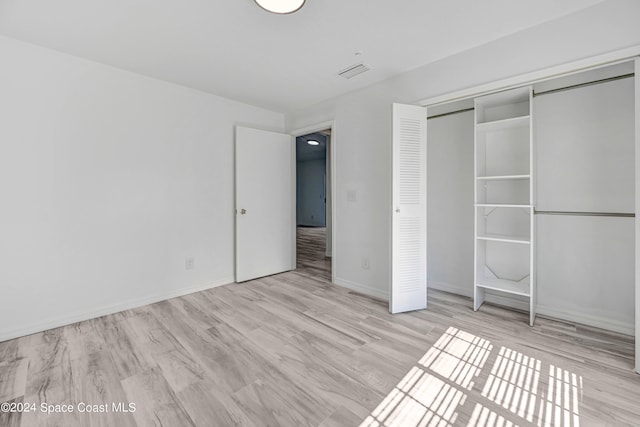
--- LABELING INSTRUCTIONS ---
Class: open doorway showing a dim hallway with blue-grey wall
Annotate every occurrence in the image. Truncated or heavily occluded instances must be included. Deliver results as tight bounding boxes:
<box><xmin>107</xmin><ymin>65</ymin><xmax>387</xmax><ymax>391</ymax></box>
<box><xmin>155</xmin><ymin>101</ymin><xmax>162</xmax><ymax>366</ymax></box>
<box><xmin>295</xmin><ymin>128</ymin><xmax>333</xmax><ymax>281</ymax></box>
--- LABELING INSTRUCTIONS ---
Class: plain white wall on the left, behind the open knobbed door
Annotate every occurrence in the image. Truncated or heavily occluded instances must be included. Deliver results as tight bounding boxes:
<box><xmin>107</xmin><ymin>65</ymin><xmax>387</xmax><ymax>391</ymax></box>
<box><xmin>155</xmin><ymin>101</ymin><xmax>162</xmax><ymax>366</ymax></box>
<box><xmin>0</xmin><ymin>38</ymin><xmax>283</xmax><ymax>341</ymax></box>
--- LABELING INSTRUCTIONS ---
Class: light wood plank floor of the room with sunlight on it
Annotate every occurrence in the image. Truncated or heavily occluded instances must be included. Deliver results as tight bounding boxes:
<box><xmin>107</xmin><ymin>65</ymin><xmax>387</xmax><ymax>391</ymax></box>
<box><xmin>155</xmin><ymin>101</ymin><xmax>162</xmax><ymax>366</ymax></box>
<box><xmin>0</xmin><ymin>231</ymin><xmax>640</xmax><ymax>427</ymax></box>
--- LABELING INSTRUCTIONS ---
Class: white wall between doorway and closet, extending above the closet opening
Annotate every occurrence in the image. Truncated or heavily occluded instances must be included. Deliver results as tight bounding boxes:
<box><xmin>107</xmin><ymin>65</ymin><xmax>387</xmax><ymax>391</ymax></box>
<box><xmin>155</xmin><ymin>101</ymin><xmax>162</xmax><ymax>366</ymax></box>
<box><xmin>286</xmin><ymin>0</ymin><xmax>640</xmax><ymax>297</ymax></box>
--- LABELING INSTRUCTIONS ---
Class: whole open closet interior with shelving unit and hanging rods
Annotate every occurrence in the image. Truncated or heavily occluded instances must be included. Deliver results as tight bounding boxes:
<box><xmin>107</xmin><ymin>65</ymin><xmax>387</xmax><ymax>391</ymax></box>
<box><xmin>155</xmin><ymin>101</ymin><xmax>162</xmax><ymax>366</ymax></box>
<box><xmin>427</xmin><ymin>60</ymin><xmax>637</xmax><ymax>335</ymax></box>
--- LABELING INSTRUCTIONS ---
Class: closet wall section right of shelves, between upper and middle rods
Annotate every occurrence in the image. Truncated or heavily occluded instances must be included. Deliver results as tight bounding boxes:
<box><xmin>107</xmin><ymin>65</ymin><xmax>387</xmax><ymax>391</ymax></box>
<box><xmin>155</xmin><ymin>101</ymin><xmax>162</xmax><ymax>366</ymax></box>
<box><xmin>534</xmin><ymin>78</ymin><xmax>636</xmax><ymax>216</ymax></box>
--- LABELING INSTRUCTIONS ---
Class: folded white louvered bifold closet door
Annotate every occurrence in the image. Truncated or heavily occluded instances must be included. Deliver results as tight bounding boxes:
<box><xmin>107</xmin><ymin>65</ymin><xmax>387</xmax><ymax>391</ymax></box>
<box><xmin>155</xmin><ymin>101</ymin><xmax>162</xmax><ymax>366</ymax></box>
<box><xmin>389</xmin><ymin>104</ymin><xmax>427</xmax><ymax>313</ymax></box>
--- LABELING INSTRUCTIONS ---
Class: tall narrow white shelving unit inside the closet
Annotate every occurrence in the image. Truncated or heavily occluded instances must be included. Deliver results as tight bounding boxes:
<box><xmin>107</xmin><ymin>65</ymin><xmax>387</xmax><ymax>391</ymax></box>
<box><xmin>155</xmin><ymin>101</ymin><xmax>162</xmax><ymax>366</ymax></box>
<box><xmin>474</xmin><ymin>87</ymin><xmax>535</xmax><ymax>326</ymax></box>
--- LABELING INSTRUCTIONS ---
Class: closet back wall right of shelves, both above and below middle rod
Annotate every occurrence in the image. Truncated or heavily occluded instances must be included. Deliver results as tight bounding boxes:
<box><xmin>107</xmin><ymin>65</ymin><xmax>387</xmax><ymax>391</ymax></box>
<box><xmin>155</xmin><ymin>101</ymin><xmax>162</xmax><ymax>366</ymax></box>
<box><xmin>534</xmin><ymin>78</ymin><xmax>636</xmax><ymax>334</ymax></box>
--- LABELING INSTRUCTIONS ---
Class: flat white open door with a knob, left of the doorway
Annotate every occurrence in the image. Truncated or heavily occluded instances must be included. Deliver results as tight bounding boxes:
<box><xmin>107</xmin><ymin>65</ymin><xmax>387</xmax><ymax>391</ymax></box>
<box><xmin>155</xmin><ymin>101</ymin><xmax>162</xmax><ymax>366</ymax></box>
<box><xmin>236</xmin><ymin>126</ymin><xmax>295</xmax><ymax>282</ymax></box>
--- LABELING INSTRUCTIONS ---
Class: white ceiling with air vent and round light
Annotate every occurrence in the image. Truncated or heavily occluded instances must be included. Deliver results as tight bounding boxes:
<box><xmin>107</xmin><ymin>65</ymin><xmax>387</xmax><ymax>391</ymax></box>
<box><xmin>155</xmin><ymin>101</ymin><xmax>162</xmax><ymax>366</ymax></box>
<box><xmin>0</xmin><ymin>0</ymin><xmax>602</xmax><ymax>112</ymax></box>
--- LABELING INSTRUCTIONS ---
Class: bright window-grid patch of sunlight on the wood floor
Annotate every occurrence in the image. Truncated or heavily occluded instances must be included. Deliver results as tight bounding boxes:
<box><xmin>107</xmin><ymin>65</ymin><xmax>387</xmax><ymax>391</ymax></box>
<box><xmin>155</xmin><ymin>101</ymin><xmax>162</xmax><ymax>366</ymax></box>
<box><xmin>360</xmin><ymin>327</ymin><xmax>582</xmax><ymax>427</ymax></box>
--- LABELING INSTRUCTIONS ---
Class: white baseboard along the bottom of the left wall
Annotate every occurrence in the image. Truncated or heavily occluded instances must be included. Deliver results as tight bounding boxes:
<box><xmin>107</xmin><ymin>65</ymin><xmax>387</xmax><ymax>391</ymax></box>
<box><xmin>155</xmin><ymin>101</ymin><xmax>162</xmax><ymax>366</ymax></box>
<box><xmin>0</xmin><ymin>277</ymin><xmax>234</xmax><ymax>342</ymax></box>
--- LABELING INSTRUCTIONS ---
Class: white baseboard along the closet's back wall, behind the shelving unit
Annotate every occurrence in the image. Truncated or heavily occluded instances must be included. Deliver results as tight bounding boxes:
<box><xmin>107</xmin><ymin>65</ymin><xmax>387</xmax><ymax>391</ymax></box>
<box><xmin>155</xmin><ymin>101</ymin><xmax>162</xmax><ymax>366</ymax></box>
<box><xmin>428</xmin><ymin>282</ymin><xmax>635</xmax><ymax>335</ymax></box>
